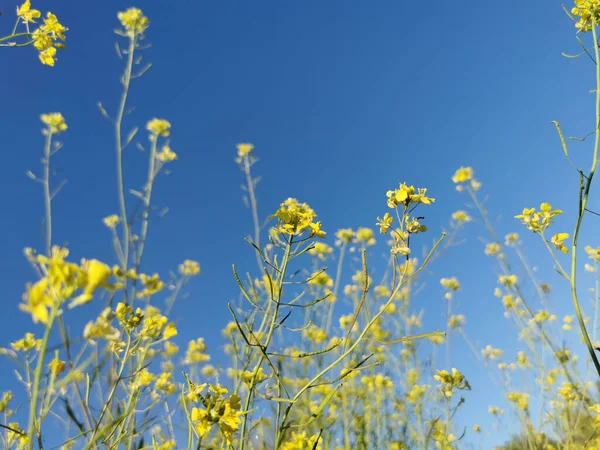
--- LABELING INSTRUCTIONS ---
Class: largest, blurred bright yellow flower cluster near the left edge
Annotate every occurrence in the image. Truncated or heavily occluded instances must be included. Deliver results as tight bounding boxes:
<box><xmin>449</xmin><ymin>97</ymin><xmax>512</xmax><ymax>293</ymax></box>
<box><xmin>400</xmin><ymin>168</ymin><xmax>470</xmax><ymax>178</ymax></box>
<box><xmin>20</xmin><ymin>247</ymin><xmax>114</xmax><ymax>323</ymax></box>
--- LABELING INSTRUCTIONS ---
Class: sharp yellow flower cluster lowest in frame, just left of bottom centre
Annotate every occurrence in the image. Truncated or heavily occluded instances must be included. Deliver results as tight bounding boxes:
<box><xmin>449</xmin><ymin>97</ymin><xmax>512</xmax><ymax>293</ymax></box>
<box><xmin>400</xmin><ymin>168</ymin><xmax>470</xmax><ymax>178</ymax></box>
<box><xmin>191</xmin><ymin>384</ymin><xmax>243</xmax><ymax>445</ymax></box>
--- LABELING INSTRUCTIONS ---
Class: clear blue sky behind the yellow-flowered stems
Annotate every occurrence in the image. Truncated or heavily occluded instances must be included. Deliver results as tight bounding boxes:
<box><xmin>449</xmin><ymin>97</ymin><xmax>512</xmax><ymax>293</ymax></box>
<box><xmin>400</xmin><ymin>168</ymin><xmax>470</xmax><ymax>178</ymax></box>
<box><xmin>0</xmin><ymin>0</ymin><xmax>600</xmax><ymax>448</ymax></box>
